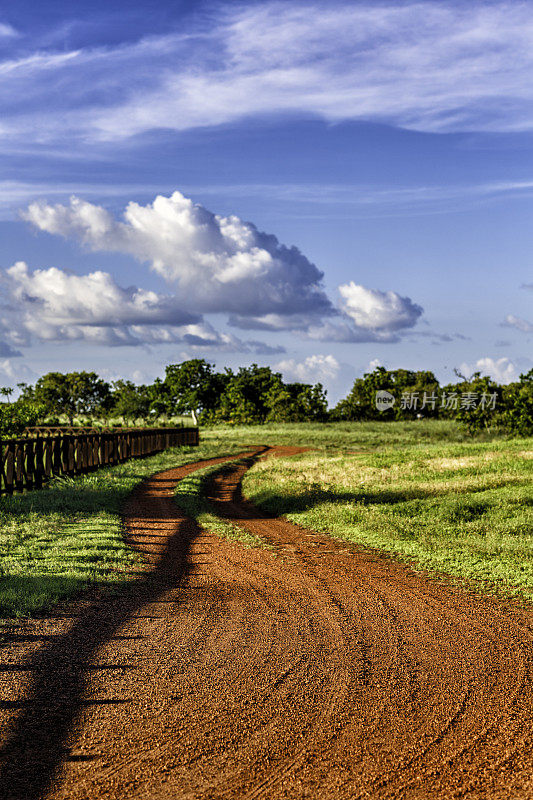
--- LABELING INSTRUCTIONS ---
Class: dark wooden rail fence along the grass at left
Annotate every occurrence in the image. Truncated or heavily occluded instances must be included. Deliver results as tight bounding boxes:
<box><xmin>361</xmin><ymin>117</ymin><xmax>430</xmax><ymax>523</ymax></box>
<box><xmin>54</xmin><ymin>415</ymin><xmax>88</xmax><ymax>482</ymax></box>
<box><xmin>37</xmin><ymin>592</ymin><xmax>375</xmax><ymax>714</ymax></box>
<box><xmin>0</xmin><ymin>428</ymin><xmax>198</xmax><ymax>494</ymax></box>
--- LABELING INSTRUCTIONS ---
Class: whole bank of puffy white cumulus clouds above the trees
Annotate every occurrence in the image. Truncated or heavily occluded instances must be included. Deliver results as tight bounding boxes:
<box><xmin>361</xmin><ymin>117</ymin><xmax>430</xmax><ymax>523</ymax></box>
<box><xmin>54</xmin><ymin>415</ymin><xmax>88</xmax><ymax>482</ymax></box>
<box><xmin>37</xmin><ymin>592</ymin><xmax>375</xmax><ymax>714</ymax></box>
<box><xmin>1</xmin><ymin>192</ymin><xmax>423</xmax><ymax>355</ymax></box>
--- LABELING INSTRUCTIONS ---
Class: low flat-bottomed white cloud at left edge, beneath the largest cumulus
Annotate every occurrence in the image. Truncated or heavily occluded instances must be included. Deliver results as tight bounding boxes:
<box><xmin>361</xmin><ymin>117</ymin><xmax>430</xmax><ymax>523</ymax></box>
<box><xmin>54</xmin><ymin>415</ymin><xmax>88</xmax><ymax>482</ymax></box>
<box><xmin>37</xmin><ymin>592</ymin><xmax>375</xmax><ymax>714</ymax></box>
<box><xmin>0</xmin><ymin>262</ymin><xmax>284</xmax><ymax>356</ymax></box>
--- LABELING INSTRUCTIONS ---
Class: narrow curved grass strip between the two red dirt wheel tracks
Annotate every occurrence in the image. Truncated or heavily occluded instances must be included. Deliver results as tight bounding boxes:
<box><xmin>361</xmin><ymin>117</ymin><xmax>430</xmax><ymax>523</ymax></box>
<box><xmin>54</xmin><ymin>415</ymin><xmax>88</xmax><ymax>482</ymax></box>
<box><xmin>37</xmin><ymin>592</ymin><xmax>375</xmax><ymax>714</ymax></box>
<box><xmin>175</xmin><ymin>462</ymin><xmax>269</xmax><ymax>547</ymax></box>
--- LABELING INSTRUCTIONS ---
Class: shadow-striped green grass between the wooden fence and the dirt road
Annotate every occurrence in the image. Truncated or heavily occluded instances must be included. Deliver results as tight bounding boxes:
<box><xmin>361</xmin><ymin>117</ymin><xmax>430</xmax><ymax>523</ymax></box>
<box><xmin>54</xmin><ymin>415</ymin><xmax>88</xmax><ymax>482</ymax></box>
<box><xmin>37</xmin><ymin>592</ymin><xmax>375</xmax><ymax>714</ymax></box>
<box><xmin>0</xmin><ymin>437</ymin><xmax>239</xmax><ymax>618</ymax></box>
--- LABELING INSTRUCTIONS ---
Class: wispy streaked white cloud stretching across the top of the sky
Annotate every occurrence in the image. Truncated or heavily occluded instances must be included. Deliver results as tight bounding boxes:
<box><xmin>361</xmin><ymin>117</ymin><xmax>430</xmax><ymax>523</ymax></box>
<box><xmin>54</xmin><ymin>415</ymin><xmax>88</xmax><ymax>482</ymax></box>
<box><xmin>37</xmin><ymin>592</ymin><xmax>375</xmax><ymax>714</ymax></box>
<box><xmin>0</xmin><ymin>0</ymin><xmax>533</xmax><ymax>146</ymax></box>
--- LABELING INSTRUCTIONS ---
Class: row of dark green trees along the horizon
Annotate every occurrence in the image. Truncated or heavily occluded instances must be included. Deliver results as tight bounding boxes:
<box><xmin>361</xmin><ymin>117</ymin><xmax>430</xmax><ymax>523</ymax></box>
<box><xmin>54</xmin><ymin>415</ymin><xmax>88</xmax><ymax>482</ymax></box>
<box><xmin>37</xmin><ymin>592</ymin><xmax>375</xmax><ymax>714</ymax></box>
<box><xmin>0</xmin><ymin>359</ymin><xmax>533</xmax><ymax>436</ymax></box>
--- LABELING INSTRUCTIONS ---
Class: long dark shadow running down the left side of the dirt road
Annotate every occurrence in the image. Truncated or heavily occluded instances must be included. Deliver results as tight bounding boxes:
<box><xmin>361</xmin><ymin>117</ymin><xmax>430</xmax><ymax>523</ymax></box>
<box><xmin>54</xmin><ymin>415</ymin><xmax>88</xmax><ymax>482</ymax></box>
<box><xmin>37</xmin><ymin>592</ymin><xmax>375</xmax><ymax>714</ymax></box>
<box><xmin>0</xmin><ymin>478</ymin><xmax>199</xmax><ymax>800</ymax></box>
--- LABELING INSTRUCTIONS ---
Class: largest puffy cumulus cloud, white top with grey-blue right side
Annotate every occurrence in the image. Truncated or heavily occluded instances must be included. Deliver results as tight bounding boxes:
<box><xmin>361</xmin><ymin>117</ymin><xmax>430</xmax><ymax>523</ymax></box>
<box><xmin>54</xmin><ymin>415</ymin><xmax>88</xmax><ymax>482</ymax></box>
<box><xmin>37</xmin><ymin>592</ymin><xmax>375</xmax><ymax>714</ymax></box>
<box><xmin>24</xmin><ymin>192</ymin><xmax>335</xmax><ymax>330</ymax></box>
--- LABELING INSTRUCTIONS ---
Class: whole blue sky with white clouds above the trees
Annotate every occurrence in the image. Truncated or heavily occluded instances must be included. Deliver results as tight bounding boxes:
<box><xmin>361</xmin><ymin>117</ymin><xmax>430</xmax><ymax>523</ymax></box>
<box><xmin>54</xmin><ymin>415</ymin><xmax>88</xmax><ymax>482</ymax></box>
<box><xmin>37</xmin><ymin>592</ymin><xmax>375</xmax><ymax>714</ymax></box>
<box><xmin>0</xmin><ymin>0</ymin><xmax>533</xmax><ymax>403</ymax></box>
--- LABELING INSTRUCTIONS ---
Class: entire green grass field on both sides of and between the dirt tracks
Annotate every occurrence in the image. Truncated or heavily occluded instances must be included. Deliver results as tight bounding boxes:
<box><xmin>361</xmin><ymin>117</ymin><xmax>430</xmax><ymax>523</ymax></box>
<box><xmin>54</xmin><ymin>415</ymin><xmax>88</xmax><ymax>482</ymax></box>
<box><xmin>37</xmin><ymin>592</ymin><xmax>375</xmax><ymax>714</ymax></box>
<box><xmin>0</xmin><ymin>420</ymin><xmax>533</xmax><ymax>618</ymax></box>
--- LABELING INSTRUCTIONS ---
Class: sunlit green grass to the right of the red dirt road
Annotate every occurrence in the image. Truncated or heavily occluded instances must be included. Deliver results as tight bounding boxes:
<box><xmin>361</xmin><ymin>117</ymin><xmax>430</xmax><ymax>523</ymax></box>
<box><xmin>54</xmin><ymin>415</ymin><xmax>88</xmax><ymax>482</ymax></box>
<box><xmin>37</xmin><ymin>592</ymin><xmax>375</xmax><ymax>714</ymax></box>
<box><xmin>243</xmin><ymin>439</ymin><xmax>533</xmax><ymax>600</ymax></box>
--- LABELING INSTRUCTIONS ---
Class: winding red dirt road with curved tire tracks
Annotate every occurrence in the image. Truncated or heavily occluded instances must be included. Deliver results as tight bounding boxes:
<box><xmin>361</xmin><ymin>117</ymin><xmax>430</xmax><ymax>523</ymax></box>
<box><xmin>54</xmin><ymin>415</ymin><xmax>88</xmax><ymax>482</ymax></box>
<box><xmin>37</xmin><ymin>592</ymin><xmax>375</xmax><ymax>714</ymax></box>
<box><xmin>0</xmin><ymin>448</ymin><xmax>533</xmax><ymax>800</ymax></box>
